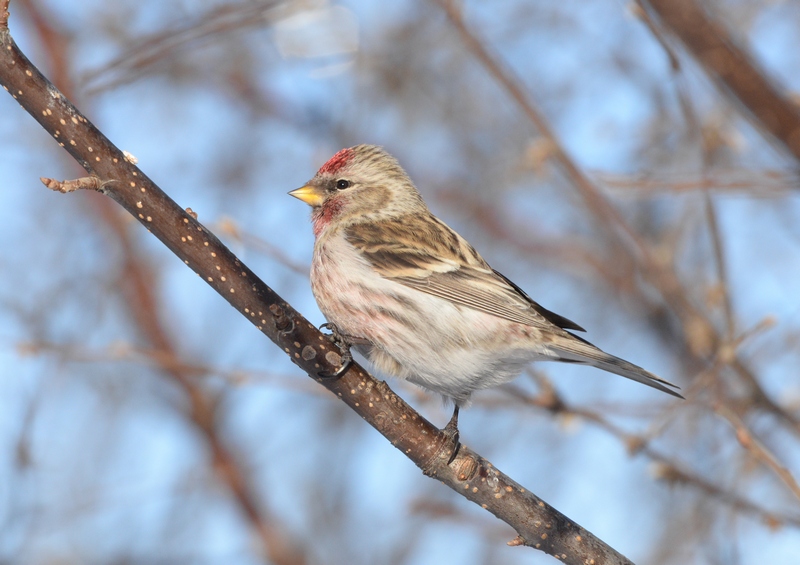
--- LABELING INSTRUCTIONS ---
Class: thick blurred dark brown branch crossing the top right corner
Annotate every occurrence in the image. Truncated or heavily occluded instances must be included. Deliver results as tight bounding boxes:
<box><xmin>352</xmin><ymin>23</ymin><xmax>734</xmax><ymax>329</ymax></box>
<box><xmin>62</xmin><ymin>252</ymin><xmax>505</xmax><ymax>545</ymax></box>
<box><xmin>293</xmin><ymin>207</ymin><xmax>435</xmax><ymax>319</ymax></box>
<box><xmin>639</xmin><ymin>0</ymin><xmax>800</xmax><ymax>165</ymax></box>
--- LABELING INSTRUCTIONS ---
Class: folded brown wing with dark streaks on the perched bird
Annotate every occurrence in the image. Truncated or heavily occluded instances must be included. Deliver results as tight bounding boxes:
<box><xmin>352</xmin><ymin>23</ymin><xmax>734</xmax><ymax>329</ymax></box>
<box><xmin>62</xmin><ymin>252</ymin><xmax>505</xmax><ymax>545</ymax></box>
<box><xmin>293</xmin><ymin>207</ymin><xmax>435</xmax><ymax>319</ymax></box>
<box><xmin>345</xmin><ymin>216</ymin><xmax>584</xmax><ymax>331</ymax></box>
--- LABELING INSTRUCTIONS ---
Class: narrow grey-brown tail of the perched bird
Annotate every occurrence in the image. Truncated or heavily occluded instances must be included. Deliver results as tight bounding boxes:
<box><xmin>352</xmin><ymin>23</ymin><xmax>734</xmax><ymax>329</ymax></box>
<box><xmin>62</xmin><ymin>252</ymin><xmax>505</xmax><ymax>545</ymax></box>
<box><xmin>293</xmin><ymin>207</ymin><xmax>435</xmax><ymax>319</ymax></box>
<box><xmin>548</xmin><ymin>332</ymin><xmax>683</xmax><ymax>398</ymax></box>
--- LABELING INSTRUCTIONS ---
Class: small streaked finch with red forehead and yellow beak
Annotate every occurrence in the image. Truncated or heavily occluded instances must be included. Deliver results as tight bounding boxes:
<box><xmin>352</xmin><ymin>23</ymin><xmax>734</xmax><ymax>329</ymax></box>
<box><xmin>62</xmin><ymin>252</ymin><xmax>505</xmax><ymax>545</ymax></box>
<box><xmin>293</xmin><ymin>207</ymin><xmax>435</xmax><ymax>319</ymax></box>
<box><xmin>289</xmin><ymin>145</ymin><xmax>683</xmax><ymax>432</ymax></box>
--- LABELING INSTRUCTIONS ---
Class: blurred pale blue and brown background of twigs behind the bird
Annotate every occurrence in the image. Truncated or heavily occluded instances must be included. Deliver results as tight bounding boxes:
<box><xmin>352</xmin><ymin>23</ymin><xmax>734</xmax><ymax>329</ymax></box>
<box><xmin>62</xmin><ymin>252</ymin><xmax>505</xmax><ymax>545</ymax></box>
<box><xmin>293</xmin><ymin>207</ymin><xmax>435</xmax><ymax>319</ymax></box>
<box><xmin>0</xmin><ymin>0</ymin><xmax>800</xmax><ymax>565</ymax></box>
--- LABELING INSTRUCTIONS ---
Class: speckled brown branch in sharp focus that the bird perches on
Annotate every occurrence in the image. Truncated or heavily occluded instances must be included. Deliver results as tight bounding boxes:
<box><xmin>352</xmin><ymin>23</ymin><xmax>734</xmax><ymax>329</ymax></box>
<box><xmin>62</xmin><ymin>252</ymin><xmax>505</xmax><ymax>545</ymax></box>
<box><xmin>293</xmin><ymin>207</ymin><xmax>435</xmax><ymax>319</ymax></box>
<box><xmin>0</xmin><ymin>4</ymin><xmax>630</xmax><ymax>565</ymax></box>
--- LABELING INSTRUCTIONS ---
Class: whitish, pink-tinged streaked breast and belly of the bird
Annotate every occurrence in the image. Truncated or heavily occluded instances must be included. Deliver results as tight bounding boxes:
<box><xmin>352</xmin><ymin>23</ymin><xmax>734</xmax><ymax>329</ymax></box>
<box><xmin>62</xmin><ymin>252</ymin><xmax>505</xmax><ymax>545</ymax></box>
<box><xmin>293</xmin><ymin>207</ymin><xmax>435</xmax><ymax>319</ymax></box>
<box><xmin>311</xmin><ymin>234</ymin><xmax>552</xmax><ymax>405</ymax></box>
